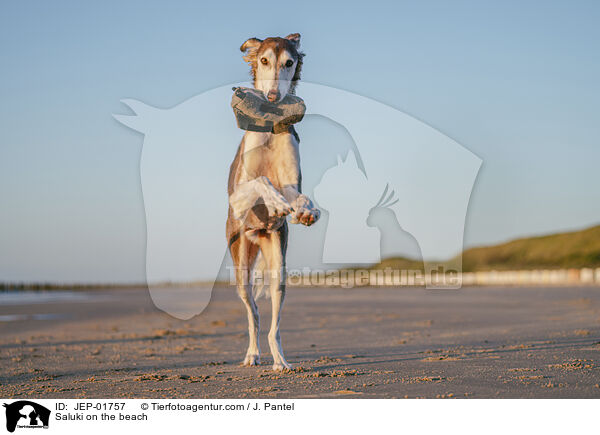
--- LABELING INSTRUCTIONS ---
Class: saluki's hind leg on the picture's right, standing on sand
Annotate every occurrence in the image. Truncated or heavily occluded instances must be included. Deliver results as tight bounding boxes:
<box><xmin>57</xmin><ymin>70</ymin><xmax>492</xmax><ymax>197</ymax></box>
<box><xmin>260</xmin><ymin>224</ymin><xmax>292</xmax><ymax>371</ymax></box>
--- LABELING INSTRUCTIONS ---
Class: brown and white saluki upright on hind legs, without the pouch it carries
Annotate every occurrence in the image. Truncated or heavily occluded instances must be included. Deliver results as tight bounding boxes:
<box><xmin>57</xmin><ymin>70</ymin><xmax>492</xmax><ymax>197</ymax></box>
<box><xmin>227</xmin><ymin>33</ymin><xmax>319</xmax><ymax>370</ymax></box>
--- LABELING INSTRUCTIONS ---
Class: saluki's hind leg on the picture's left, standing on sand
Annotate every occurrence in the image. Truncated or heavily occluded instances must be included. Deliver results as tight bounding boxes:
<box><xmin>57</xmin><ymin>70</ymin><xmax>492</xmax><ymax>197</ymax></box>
<box><xmin>231</xmin><ymin>233</ymin><xmax>260</xmax><ymax>366</ymax></box>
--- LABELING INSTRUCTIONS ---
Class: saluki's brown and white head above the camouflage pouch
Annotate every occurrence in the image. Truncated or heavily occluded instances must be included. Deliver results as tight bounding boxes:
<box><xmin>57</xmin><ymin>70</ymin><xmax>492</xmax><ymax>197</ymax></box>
<box><xmin>240</xmin><ymin>33</ymin><xmax>304</xmax><ymax>103</ymax></box>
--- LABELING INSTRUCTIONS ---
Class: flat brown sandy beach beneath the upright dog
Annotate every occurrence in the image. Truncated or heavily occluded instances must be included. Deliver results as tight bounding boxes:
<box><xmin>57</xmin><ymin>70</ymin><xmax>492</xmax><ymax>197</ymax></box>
<box><xmin>0</xmin><ymin>287</ymin><xmax>600</xmax><ymax>398</ymax></box>
